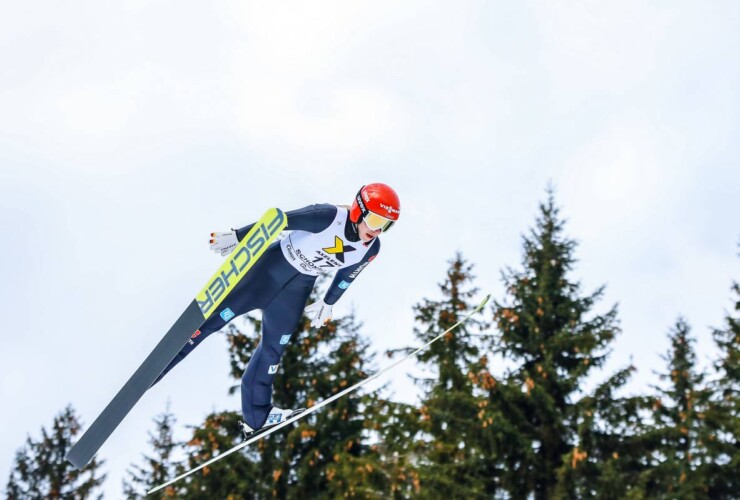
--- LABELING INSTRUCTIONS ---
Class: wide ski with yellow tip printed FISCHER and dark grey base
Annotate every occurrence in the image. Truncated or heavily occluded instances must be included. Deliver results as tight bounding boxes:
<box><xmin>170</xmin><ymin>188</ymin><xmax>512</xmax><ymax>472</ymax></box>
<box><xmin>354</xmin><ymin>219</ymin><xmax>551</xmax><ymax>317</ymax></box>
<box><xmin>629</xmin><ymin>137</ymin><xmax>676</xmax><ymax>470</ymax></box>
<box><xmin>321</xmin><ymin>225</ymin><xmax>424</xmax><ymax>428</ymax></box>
<box><xmin>66</xmin><ymin>208</ymin><xmax>288</xmax><ymax>469</ymax></box>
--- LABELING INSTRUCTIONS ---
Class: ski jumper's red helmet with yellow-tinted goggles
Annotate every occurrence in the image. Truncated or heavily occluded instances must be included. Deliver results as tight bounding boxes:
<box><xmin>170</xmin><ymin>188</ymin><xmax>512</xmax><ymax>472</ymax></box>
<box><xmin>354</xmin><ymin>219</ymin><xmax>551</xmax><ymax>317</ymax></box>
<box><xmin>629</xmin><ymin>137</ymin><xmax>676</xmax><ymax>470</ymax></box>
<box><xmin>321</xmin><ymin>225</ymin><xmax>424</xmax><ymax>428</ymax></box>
<box><xmin>349</xmin><ymin>182</ymin><xmax>401</xmax><ymax>231</ymax></box>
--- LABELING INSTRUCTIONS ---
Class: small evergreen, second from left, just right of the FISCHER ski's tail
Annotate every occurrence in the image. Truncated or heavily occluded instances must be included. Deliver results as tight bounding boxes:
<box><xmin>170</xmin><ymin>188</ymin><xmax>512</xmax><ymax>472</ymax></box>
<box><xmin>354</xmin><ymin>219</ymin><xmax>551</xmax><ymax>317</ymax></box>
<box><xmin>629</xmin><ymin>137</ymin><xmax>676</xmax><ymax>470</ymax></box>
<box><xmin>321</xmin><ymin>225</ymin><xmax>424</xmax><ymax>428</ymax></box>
<box><xmin>123</xmin><ymin>404</ymin><xmax>184</xmax><ymax>499</ymax></box>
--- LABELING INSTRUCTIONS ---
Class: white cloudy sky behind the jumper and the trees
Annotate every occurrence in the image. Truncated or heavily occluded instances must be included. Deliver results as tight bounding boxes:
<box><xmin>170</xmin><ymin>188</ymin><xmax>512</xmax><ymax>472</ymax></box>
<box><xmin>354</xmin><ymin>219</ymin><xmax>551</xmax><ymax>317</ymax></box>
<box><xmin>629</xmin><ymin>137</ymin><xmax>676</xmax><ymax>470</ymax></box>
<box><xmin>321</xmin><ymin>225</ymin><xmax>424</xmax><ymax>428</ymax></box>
<box><xmin>0</xmin><ymin>0</ymin><xmax>740</xmax><ymax>497</ymax></box>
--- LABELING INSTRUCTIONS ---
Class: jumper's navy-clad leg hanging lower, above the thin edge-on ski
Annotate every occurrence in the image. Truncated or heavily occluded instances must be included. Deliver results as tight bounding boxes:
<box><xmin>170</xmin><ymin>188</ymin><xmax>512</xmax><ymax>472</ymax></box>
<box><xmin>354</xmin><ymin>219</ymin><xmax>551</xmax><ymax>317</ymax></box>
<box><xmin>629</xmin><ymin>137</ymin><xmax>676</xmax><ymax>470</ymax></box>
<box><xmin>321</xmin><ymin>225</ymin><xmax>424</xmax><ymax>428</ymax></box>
<box><xmin>242</xmin><ymin>276</ymin><xmax>313</xmax><ymax>429</ymax></box>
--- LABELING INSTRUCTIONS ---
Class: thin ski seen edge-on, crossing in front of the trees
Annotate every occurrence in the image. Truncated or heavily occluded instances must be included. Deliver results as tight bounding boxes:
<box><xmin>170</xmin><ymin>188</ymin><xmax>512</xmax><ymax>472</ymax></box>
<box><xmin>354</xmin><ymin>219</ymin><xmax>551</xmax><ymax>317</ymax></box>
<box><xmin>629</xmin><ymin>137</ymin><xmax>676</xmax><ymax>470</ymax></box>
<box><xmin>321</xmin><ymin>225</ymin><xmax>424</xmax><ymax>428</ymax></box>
<box><xmin>147</xmin><ymin>294</ymin><xmax>491</xmax><ymax>495</ymax></box>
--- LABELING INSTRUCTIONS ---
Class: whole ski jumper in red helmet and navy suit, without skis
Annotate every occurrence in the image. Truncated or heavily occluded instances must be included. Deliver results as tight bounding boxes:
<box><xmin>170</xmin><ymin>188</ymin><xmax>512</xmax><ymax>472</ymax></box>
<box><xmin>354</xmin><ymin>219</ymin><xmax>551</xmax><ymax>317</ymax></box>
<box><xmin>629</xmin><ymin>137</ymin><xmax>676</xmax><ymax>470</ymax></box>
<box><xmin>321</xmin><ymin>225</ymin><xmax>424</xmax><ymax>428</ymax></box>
<box><xmin>155</xmin><ymin>183</ymin><xmax>401</xmax><ymax>433</ymax></box>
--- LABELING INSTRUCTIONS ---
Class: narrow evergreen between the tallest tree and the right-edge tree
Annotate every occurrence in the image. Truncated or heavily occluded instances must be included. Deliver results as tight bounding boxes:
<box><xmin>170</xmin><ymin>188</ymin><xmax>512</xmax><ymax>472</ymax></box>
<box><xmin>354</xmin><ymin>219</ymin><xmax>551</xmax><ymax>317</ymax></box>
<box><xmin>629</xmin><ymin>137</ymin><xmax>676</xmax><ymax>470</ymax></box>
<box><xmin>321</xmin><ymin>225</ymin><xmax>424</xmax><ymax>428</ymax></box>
<box><xmin>640</xmin><ymin>319</ymin><xmax>710</xmax><ymax>498</ymax></box>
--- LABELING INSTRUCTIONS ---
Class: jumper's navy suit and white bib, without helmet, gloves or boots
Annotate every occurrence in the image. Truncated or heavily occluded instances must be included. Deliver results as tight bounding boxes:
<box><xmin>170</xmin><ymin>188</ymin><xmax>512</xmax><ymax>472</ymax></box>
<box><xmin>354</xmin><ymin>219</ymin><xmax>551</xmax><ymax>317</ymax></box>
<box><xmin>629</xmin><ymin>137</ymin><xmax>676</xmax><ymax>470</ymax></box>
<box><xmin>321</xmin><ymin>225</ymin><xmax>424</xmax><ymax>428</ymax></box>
<box><xmin>154</xmin><ymin>204</ymin><xmax>380</xmax><ymax>429</ymax></box>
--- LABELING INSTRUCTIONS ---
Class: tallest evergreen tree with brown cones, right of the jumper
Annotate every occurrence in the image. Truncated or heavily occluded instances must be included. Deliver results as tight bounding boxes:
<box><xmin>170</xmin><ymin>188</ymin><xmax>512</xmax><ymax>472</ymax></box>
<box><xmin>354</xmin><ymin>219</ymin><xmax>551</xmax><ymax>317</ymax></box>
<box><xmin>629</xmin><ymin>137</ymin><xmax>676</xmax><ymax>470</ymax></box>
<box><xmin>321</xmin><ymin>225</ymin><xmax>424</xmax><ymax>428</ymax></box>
<box><xmin>478</xmin><ymin>190</ymin><xmax>640</xmax><ymax>499</ymax></box>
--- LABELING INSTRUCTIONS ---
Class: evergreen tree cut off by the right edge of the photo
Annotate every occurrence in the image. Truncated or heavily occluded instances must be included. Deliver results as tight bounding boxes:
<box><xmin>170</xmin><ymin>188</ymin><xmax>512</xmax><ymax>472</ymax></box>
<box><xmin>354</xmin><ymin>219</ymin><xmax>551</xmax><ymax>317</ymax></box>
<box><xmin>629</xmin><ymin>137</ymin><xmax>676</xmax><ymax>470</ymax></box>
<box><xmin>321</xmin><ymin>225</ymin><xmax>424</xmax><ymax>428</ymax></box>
<box><xmin>705</xmin><ymin>283</ymin><xmax>740</xmax><ymax>498</ymax></box>
